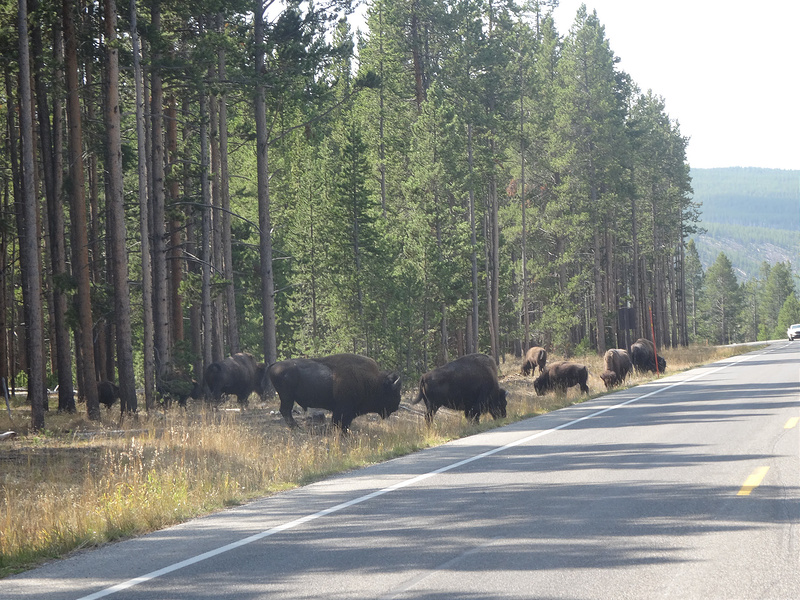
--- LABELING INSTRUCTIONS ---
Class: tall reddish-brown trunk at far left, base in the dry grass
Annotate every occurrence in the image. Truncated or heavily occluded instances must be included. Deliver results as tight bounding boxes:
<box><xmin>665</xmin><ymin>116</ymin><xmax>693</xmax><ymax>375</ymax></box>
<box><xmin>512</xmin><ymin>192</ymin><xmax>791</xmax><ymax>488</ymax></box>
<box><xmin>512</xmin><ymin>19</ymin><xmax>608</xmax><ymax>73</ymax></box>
<box><xmin>62</xmin><ymin>0</ymin><xmax>100</xmax><ymax>421</ymax></box>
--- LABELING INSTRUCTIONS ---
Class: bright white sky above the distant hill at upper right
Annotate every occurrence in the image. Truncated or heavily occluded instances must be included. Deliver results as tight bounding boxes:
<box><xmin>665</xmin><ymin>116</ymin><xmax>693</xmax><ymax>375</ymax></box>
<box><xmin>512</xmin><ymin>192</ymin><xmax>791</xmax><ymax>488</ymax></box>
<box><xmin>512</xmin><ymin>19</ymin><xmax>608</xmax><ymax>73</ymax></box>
<box><xmin>553</xmin><ymin>0</ymin><xmax>800</xmax><ymax>170</ymax></box>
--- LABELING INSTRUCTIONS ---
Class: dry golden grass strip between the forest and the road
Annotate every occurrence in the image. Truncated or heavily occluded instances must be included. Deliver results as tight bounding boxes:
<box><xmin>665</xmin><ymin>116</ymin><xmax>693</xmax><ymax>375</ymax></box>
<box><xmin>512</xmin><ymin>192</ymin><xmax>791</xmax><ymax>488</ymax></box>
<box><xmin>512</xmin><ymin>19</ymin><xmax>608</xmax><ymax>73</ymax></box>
<box><xmin>0</xmin><ymin>347</ymin><xmax>760</xmax><ymax>577</ymax></box>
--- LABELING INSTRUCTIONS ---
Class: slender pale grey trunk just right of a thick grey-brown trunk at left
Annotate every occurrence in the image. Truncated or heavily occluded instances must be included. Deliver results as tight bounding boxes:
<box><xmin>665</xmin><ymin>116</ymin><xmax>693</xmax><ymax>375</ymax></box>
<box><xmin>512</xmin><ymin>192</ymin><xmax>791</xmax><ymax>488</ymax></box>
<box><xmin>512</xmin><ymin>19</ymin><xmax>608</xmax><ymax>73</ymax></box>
<box><xmin>130</xmin><ymin>0</ymin><xmax>155</xmax><ymax>412</ymax></box>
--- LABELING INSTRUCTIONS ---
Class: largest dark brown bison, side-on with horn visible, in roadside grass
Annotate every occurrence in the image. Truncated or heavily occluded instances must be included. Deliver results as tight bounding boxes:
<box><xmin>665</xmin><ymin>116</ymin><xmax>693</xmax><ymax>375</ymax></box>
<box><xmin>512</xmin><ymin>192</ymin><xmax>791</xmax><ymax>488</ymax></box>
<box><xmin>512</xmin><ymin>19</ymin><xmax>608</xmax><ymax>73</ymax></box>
<box><xmin>267</xmin><ymin>354</ymin><xmax>401</xmax><ymax>431</ymax></box>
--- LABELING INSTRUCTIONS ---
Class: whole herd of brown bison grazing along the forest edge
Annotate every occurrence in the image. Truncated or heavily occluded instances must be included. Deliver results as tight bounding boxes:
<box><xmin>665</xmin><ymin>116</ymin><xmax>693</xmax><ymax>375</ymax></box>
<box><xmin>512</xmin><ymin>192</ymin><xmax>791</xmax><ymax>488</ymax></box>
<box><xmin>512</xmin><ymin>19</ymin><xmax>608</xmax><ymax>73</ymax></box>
<box><xmin>92</xmin><ymin>339</ymin><xmax>667</xmax><ymax>431</ymax></box>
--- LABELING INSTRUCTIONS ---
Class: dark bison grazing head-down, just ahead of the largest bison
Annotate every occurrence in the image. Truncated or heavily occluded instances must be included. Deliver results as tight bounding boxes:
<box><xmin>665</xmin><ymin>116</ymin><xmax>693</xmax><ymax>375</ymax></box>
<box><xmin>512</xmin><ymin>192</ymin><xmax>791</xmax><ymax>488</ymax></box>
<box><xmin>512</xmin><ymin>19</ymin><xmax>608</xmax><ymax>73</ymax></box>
<box><xmin>412</xmin><ymin>354</ymin><xmax>507</xmax><ymax>425</ymax></box>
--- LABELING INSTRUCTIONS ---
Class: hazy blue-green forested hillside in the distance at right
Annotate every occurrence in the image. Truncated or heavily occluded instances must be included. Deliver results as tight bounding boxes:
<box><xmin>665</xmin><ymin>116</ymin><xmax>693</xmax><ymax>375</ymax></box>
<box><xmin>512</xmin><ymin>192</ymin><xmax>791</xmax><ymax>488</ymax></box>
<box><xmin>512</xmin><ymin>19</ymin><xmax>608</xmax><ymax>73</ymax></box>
<box><xmin>691</xmin><ymin>167</ymin><xmax>800</xmax><ymax>280</ymax></box>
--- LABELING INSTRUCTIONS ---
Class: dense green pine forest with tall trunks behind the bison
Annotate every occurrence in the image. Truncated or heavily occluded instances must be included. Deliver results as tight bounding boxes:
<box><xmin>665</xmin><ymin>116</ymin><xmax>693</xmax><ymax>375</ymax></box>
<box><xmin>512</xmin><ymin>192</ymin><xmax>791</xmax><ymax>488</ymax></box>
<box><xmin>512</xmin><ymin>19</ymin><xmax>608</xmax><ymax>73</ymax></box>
<box><xmin>0</xmin><ymin>0</ymin><xmax>800</xmax><ymax>427</ymax></box>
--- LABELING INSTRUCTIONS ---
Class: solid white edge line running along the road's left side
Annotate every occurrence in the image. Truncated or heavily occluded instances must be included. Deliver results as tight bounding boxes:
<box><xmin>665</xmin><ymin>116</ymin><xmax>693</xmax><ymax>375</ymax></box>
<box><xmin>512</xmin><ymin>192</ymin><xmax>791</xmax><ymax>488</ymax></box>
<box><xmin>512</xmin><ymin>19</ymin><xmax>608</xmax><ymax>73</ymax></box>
<box><xmin>77</xmin><ymin>350</ymin><xmax>769</xmax><ymax>600</ymax></box>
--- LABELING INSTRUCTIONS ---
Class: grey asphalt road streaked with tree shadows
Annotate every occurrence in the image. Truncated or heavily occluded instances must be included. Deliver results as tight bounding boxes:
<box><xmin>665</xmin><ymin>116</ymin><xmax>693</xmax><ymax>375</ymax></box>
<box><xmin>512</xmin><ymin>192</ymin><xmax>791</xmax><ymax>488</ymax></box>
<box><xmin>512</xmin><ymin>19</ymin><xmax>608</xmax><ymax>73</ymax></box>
<box><xmin>6</xmin><ymin>342</ymin><xmax>800</xmax><ymax>600</ymax></box>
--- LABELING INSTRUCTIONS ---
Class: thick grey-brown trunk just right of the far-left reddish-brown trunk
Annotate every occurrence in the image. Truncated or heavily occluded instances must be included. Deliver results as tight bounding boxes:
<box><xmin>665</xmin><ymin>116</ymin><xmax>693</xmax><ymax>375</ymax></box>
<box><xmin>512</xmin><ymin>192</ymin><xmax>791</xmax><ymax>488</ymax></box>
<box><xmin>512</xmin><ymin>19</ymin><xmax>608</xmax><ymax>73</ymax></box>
<box><xmin>103</xmin><ymin>0</ymin><xmax>138</xmax><ymax>413</ymax></box>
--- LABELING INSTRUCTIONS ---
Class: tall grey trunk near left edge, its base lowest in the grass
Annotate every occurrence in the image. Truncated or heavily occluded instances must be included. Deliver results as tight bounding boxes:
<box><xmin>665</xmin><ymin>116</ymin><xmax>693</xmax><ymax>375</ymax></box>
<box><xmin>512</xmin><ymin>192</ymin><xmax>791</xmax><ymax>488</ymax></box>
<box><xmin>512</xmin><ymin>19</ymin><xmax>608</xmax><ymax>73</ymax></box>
<box><xmin>18</xmin><ymin>0</ymin><xmax>47</xmax><ymax>431</ymax></box>
